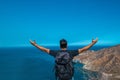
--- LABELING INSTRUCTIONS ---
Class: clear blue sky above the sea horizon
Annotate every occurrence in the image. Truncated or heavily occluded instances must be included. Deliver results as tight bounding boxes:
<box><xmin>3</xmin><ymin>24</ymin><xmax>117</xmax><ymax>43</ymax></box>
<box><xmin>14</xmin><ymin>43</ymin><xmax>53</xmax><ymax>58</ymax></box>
<box><xmin>0</xmin><ymin>0</ymin><xmax>120</xmax><ymax>47</ymax></box>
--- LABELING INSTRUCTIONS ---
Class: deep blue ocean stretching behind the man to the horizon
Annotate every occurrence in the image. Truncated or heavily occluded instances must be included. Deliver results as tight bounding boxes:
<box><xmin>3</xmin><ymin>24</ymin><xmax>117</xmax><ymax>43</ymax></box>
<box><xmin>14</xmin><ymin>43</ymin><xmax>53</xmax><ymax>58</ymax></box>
<box><xmin>0</xmin><ymin>46</ymin><xmax>109</xmax><ymax>80</ymax></box>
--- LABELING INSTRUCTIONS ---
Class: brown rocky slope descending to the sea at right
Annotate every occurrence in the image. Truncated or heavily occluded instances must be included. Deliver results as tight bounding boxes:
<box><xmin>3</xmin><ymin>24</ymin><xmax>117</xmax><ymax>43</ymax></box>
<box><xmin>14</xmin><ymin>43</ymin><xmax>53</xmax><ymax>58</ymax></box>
<box><xmin>74</xmin><ymin>45</ymin><xmax>120</xmax><ymax>80</ymax></box>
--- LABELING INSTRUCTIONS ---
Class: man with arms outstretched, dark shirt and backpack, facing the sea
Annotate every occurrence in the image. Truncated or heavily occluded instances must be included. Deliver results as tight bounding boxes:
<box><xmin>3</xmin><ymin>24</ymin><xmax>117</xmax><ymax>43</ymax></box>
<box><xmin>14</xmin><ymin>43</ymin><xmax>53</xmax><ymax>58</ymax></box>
<box><xmin>30</xmin><ymin>38</ymin><xmax>98</xmax><ymax>80</ymax></box>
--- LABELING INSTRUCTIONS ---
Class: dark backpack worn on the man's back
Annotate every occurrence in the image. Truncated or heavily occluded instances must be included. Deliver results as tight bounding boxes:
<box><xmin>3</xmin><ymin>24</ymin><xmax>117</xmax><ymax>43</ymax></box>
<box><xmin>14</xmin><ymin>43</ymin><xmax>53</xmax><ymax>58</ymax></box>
<box><xmin>55</xmin><ymin>51</ymin><xmax>74</xmax><ymax>80</ymax></box>
